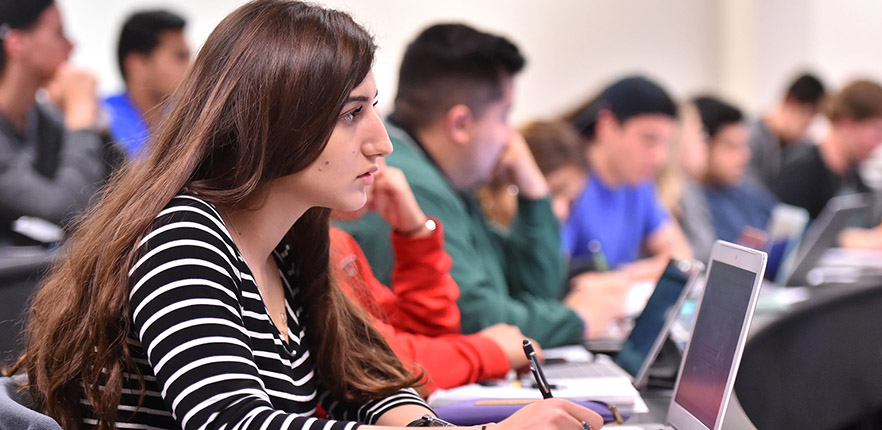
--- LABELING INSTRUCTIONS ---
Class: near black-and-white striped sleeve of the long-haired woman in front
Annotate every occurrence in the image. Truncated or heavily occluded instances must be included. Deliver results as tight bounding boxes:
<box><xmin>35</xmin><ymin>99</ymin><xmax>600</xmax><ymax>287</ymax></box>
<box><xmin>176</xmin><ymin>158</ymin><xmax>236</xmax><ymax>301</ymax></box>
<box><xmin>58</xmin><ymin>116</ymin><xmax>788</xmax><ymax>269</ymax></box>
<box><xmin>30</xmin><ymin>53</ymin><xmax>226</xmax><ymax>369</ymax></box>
<box><xmin>129</xmin><ymin>199</ymin><xmax>358</xmax><ymax>430</ymax></box>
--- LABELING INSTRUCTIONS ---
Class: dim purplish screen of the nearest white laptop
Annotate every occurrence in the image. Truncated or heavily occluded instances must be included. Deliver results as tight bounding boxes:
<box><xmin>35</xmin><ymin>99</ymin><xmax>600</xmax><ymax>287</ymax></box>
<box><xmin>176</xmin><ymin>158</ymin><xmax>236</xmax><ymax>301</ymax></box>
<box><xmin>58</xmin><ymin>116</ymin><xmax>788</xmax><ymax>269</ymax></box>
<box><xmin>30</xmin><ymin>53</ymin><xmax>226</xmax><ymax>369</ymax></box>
<box><xmin>674</xmin><ymin>260</ymin><xmax>756</xmax><ymax>428</ymax></box>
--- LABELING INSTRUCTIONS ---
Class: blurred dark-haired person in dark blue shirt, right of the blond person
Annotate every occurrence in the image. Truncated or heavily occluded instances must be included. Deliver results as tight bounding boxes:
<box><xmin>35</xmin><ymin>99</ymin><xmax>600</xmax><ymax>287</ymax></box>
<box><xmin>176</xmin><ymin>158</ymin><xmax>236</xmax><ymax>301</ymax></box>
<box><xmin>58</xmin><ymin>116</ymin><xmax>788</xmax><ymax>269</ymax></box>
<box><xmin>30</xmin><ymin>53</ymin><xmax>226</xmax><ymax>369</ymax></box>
<box><xmin>693</xmin><ymin>96</ymin><xmax>778</xmax><ymax>242</ymax></box>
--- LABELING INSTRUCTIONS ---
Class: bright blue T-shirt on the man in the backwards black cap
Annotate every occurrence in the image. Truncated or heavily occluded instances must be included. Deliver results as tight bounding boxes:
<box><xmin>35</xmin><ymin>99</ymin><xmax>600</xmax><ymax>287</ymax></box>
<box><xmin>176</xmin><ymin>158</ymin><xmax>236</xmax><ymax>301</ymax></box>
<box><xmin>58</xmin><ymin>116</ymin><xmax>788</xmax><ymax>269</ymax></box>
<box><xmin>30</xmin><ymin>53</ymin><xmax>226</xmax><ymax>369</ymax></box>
<box><xmin>562</xmin><ymin>173</ymin><xmax>670</xmax><ymax>268</ymax></box>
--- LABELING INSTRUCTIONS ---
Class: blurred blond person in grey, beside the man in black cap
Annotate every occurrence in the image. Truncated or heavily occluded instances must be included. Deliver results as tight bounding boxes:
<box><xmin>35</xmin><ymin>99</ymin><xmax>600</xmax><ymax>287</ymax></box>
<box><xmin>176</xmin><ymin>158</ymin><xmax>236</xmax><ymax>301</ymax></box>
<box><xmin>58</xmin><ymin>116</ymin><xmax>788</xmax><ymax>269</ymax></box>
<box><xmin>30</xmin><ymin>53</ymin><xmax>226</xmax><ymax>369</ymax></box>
<box><xmin>655</xmin><ymin>102</ymin><xmax>717</xmax><ymax>261</ymax></box>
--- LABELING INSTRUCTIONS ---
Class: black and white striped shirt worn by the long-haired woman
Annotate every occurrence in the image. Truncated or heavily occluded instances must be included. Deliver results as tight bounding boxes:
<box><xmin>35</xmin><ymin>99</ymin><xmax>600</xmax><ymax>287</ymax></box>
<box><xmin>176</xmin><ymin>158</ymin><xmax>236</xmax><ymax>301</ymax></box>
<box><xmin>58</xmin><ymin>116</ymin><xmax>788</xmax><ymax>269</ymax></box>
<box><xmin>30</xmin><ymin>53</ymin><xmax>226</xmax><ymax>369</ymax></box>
<box><xmin>84</xmin><ymin>196</ymin><xmax>428</xmax><ymax>430</ymax></box>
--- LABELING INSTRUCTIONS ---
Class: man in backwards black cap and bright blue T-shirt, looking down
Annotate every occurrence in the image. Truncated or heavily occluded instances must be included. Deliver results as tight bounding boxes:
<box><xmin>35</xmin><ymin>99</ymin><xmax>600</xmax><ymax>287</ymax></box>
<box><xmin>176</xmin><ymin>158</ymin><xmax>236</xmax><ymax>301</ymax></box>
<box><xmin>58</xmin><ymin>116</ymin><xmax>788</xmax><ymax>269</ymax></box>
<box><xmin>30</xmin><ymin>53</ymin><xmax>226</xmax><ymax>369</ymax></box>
<box><xmin>562</xmin><ymin>76</ymin><xmax>692</xmax><ymax>277</ymax></box>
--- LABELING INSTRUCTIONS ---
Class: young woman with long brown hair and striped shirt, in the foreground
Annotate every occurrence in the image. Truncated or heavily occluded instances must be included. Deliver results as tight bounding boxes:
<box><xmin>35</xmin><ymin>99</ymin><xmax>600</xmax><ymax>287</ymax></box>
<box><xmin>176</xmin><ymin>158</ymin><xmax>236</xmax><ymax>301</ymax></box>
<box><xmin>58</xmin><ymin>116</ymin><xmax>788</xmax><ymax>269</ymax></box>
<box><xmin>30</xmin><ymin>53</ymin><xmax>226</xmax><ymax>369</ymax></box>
<box><xmin>17</xmin><ymin>0</ymin><xmax>602</xmax><ymax>429</ymax></box>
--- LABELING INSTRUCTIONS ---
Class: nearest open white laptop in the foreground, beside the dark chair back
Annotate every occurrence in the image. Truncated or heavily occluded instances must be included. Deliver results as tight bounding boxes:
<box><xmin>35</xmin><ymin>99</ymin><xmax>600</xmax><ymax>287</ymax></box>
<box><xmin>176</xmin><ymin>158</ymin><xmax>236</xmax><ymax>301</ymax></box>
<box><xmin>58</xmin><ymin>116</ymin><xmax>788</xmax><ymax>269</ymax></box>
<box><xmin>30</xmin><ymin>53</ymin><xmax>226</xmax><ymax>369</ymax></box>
<box><xmin>616</xmin><ymin>241</ymin><xmax>767</xmax><ymax>430</ymax></box>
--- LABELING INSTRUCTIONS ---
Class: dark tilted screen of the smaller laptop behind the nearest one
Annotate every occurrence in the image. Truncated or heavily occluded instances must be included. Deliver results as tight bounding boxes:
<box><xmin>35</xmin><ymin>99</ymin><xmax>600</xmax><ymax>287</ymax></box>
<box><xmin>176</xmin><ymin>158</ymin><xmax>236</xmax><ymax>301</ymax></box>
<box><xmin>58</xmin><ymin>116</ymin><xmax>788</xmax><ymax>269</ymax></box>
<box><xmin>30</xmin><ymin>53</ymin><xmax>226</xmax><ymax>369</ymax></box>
<box><xmin>616</xmin><ymin>262</ymin><xmax>688</xmax><ymax>376</ymax></box>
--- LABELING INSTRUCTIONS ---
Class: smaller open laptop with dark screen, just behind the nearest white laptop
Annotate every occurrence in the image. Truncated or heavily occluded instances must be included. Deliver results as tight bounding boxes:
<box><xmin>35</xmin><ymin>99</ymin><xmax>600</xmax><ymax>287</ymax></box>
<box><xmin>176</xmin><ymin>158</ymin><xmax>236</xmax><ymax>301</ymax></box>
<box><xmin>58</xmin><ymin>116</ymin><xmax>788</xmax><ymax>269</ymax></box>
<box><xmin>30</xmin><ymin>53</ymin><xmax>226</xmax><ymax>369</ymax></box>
<box><xmin>526</xmin><ymin>260</ymin><xmax>704</xmax><ymax>388</ymax></box>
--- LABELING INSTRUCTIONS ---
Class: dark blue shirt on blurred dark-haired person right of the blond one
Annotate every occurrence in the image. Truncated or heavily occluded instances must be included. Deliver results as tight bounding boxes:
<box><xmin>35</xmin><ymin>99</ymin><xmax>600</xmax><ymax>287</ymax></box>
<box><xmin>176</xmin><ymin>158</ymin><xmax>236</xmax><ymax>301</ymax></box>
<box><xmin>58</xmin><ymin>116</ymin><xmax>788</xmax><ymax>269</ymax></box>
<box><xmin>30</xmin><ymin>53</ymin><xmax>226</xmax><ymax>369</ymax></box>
<box><xmin>704</xmin><ymin>182</ymin><xmax>778</xmax><ymax>242</ymax></box>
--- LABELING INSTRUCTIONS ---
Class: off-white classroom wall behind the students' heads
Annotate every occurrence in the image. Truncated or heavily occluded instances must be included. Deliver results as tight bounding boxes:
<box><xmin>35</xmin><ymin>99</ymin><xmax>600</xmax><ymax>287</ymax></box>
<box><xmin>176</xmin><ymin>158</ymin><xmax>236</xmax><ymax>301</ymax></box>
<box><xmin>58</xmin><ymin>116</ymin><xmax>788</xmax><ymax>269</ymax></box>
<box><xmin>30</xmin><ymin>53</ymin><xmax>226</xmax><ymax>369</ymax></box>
<box><xmin>58</xmin><ymin>0</ymin><xmax>882</xmax><ymax>122</ymax></box>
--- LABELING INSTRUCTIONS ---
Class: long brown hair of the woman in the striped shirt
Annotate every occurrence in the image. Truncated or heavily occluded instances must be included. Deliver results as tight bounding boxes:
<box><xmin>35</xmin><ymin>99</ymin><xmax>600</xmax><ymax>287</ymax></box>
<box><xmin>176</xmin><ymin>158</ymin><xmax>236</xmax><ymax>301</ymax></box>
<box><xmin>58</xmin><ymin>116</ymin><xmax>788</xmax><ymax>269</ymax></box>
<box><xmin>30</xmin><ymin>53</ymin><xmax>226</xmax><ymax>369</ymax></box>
<box><xmin>23</xmin><ymin>0</ymin><xmax>416</xmax><ymax>429</ymax></box>
